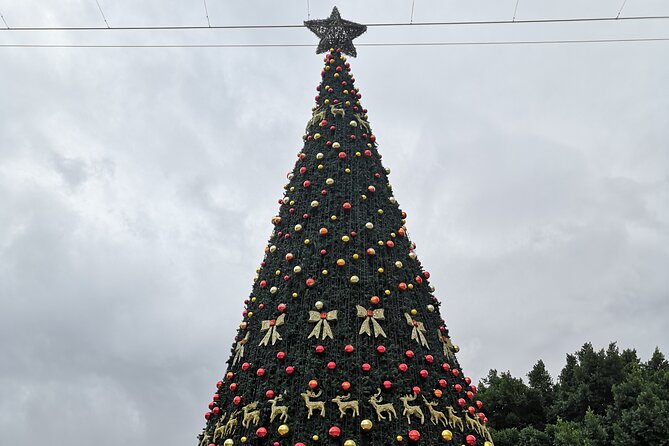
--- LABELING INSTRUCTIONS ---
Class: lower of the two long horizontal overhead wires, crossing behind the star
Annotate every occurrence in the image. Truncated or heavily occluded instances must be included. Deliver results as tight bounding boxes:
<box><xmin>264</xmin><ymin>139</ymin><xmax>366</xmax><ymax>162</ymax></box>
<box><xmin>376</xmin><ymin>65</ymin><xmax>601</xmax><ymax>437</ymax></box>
<box><xmin>0</xmin><ymin>37</ymin><xmax>669</xmax><ymax>48</ymax></box>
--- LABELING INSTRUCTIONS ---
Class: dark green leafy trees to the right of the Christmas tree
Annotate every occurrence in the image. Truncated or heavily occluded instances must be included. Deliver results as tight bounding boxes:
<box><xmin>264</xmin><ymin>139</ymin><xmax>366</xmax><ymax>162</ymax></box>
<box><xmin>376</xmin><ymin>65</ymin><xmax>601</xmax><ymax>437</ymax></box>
<box><xmin>477</xmin><ymin>343</ymin><xmax>669</xmax><ymax>446</ymax></box>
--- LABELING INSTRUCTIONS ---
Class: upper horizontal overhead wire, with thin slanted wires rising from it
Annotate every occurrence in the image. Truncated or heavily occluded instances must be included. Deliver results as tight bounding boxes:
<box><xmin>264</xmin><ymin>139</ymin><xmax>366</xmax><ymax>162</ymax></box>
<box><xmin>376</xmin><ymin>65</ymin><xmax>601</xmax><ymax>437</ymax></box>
<box><xmin>0</xmin><ymin>14</ymin><xmax>669</xmax><ymax>31</ymax></box>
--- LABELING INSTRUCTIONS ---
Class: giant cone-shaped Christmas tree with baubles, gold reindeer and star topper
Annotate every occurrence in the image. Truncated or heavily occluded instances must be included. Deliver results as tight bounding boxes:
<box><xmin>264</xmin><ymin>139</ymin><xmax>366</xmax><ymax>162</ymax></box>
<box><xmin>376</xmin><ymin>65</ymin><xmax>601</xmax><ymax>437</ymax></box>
<box><xmin>199</xmin><ymin>8</ymin><xmax>492</xmax><ymax>446</ymax></box>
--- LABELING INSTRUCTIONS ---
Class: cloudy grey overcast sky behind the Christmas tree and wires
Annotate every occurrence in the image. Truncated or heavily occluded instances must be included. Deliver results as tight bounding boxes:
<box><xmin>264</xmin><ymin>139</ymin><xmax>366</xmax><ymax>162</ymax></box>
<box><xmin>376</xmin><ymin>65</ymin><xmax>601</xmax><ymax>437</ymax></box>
<box><xmin>0</xmin><ymin>0</ymin><xmax>669</xmax><ymax>446</ymax></box>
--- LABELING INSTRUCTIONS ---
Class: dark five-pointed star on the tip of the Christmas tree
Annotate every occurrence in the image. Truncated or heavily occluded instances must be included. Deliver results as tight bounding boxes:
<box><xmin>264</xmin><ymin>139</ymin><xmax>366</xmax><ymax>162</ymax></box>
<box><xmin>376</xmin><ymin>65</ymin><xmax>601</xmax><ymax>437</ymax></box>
<box><xmin>304</xmin><ymin>6</ymin><xmax>367</xmax><ymax>57</ymax></box>
